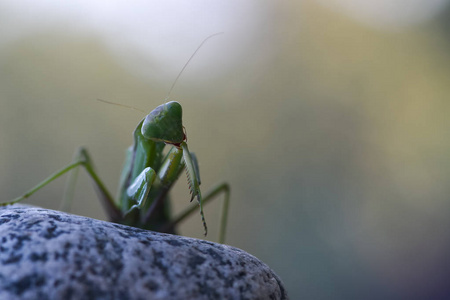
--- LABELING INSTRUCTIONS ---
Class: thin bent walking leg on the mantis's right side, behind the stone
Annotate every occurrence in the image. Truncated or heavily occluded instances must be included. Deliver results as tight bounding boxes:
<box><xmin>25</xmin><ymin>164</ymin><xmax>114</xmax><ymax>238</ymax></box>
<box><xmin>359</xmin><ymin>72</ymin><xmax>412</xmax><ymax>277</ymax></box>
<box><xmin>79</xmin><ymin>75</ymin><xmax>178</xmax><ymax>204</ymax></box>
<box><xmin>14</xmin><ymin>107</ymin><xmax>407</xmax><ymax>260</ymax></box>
<box><xmin>163</xmin><ymin>183</ymin><xmax>230</xmax><ymax>244</ymax></box>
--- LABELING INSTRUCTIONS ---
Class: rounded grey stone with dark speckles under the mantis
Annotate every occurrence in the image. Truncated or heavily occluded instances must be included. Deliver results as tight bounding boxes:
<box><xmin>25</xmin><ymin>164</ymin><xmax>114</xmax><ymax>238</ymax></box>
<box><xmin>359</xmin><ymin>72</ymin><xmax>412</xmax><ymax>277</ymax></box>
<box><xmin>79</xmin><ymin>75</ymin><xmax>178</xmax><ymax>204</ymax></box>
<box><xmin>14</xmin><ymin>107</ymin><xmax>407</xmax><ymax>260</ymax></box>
<box><xmin>0</xmin><ymin>205</ymin><xmax>287</xmax><ymax>300</ymax></box>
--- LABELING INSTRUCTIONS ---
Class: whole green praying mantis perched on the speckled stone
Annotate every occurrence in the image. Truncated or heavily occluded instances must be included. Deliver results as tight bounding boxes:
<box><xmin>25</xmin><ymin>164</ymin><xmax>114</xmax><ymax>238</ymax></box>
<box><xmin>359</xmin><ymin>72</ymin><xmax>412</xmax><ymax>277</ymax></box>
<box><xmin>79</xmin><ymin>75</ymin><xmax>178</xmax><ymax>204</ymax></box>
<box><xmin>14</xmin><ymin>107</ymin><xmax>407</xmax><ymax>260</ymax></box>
<box><xmin>0</xmin><ymin>34</ymin><xmax>230</xmax><ymax>243</ymax></box>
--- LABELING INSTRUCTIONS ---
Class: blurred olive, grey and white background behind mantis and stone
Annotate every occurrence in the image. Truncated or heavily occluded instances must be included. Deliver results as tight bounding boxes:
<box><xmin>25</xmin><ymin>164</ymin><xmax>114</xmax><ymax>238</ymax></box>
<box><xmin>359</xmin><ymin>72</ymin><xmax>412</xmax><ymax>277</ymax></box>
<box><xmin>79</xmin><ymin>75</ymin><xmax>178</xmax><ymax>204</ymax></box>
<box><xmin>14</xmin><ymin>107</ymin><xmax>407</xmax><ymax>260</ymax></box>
<box><xmin>0</xmin><ymin>0</ymin><xmax>450</xmax><ymax>299</ymax></box>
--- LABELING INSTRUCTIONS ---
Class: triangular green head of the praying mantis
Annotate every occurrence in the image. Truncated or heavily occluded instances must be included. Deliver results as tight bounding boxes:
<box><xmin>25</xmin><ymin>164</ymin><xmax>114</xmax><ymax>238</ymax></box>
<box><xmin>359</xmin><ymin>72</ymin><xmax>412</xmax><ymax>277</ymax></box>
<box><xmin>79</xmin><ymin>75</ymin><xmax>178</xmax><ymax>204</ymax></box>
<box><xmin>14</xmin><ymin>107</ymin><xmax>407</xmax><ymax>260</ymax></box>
<box><xmin>141</xmin><ymin>101</ymin><xmax>186</xmax><ymax>145</ymax></box>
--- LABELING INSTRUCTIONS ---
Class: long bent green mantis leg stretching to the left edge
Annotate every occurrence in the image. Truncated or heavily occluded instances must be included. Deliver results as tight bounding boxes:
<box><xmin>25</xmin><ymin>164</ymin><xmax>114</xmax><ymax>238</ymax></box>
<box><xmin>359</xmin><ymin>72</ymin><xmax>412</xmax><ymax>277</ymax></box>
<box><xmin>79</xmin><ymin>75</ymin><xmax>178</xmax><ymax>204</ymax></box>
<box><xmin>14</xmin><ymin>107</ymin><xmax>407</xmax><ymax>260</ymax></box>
<box><xmin>0</xmin><ymin>148</ymin><xmax>121</xmax><ymax>221</ymax></box>
